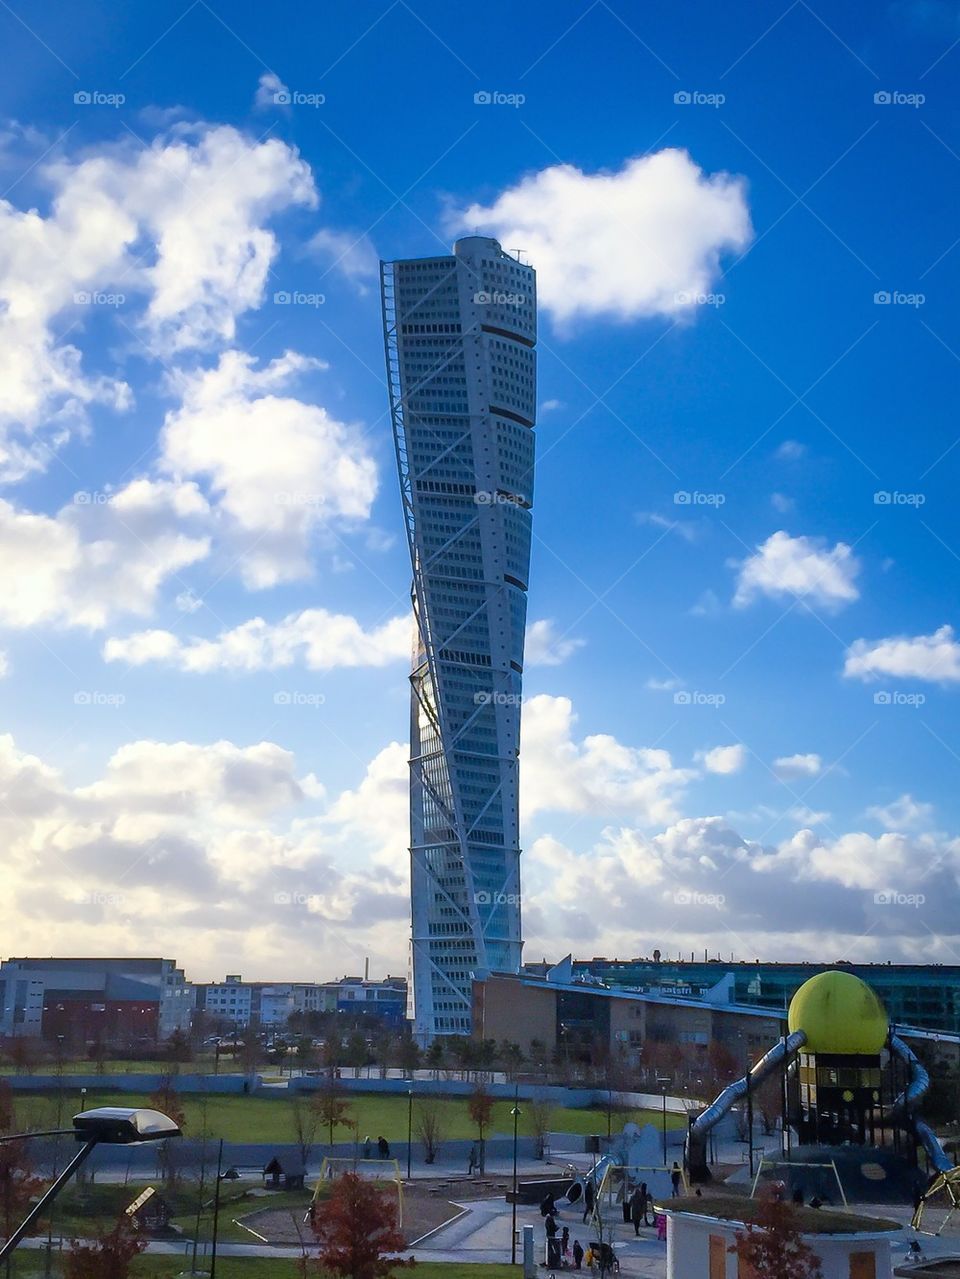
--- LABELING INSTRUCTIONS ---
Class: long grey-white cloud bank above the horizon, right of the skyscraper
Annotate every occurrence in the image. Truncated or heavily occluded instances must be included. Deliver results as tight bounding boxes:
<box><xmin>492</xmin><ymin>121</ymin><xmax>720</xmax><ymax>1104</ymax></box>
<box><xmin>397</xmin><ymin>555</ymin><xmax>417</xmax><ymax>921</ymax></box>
<box><xmin>524</xmin><ymin>817</ymin><xmax>960</xmax><ymax>962</ymax></box>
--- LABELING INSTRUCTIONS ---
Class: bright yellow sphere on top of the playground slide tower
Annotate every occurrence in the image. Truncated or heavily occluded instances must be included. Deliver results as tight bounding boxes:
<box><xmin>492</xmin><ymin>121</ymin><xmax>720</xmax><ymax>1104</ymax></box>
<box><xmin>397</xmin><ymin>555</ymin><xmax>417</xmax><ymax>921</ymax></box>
<box><xmin>787</xmin><ymin>969</ymin><xmax>890</xmax><ymax>1055</ymax></box>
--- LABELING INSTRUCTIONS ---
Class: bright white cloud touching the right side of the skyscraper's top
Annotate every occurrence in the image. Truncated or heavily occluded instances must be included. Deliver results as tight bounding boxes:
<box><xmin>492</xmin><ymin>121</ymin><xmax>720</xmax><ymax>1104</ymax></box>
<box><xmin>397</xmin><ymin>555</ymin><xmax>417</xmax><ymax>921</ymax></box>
<box><xmin>453</xmin><ymin>150</ymin><xmax>753</xmax><ymax>325</ymax></box>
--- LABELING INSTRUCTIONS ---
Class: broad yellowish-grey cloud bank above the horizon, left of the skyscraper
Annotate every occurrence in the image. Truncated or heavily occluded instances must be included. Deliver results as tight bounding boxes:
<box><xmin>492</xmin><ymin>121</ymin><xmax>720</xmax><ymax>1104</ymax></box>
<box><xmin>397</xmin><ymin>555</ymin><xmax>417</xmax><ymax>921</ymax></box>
<box><xmin>0</xmin><ymin>735</ymin><xmax>408</xmax><ymax>976</ymax></box>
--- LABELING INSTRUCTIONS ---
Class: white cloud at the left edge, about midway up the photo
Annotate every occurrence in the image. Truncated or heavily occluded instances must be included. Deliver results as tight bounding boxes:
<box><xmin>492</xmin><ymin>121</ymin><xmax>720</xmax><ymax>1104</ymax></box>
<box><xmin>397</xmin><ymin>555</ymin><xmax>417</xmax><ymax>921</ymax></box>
<box><xmin>0</xmin><ymin>480</ymin><xmax>210</xmax><ymax>629</ymax></box>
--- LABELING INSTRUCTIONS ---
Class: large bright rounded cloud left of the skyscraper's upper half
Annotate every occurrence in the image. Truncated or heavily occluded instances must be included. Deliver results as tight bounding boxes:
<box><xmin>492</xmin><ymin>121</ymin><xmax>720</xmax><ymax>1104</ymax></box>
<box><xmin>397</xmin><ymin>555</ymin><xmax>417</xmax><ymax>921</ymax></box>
<box><xmin>160</xmin><ymin>350</ymin><xmax>377</xmax><ymax>587</ymax></box>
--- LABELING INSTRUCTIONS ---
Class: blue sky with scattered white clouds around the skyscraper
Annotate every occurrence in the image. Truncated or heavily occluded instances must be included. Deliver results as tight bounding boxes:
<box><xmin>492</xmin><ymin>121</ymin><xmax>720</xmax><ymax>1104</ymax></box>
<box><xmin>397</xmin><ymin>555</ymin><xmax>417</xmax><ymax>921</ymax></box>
<box><xmin>0</xmin><ymin>0</ymin><xmax>960</xmax><ymax>976</ymax></box>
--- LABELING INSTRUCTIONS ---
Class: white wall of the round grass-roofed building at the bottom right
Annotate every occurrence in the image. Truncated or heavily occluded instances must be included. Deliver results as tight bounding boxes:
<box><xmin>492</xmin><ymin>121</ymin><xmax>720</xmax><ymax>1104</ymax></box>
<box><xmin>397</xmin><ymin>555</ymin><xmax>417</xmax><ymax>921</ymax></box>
<box><xmin>667</xmin><ymin>1212</ymin><xmax>894</xmax><ymax>1279</ymax></box>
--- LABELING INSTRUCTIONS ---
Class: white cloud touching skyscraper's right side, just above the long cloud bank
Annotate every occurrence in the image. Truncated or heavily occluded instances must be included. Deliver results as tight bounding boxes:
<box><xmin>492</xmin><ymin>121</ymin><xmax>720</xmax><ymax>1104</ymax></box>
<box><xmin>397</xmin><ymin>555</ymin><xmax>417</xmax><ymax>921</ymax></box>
<box><xmin>520</xmin><ymin>693</ymin><xmax>694</xmax><ymax>825</ymax></box>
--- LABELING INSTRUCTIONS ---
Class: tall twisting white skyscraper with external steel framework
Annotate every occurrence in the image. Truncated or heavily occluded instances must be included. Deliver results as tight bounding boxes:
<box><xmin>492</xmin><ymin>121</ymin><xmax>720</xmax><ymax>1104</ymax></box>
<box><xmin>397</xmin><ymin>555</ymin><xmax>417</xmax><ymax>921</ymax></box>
<box><xmin>381</xmin><ymin>237</ymin><xmax>537</xmax><ymax>1042</ymax></box>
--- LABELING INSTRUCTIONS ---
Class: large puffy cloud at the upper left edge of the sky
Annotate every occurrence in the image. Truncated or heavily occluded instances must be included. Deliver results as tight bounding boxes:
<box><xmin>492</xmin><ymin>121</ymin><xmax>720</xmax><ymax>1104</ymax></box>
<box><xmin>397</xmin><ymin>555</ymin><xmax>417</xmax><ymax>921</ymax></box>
<box><xmin>0</xmin><ymin>125</ymin><xmax>316</xmax><ymax>481</ymax></box>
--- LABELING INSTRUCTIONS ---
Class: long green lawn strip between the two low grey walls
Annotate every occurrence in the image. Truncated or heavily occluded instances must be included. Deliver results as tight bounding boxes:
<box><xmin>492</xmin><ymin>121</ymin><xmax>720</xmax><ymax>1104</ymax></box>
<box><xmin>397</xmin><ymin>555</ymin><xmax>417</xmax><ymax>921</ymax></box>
<box><xmin>9</xmin><ymin>1088</ymin><xmax>686</xmax><ymax>1150</ymax></box>
